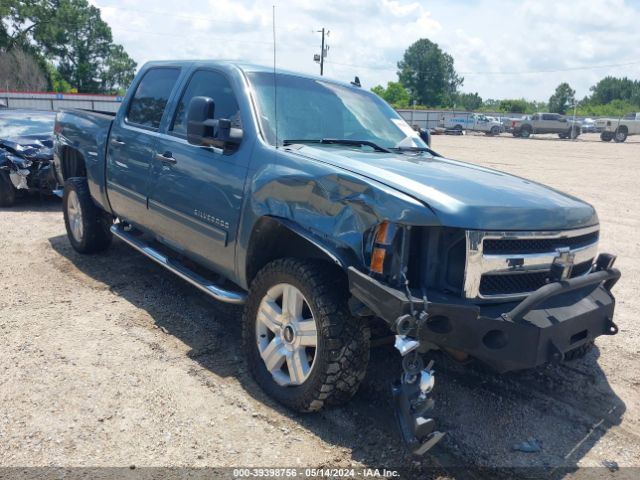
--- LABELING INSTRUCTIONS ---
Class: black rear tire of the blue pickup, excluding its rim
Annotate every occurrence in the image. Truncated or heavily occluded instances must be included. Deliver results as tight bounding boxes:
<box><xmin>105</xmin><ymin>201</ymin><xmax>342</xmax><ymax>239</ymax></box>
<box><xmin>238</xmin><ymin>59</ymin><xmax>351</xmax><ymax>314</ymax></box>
<box><xmin>62</xmin><ymin>177</ymin><xmax>113</xmax><ymax>253</ymax></box>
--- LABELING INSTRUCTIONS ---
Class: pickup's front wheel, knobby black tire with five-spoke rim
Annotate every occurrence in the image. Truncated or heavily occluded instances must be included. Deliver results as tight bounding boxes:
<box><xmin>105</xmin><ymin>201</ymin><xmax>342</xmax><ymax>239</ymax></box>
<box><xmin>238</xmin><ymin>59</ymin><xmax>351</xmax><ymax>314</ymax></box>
<box><xmin>243</xmin><ymin>258</ymin><xmax>369</xmax><ymax>412</ymax></box>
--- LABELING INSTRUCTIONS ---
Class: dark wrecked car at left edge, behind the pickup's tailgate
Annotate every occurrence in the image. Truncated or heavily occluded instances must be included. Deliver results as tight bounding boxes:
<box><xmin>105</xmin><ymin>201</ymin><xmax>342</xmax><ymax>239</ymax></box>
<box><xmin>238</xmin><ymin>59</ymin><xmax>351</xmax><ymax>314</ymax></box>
<box><xmin>0</xmin><ymin>109</ymin><xmax>57</xmax><ymax>207</ymax></box>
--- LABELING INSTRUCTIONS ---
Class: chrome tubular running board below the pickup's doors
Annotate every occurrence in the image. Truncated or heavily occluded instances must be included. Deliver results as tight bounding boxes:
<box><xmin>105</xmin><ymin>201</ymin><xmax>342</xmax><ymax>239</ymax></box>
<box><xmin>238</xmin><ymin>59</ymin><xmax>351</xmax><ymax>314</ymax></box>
<box><xmin>111</xmin><ymin>224</ymin><xmax>247</xmax><ymax>305</ymax></box>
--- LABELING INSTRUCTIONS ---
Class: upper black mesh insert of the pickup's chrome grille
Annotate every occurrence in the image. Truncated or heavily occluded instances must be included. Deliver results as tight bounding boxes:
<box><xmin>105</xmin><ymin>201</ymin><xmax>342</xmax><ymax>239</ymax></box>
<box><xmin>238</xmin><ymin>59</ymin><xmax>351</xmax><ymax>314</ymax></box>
<box><xmin>483</xmin><ymin>231</ymin><xmax>599</xmax><ymax>255</ymax></box>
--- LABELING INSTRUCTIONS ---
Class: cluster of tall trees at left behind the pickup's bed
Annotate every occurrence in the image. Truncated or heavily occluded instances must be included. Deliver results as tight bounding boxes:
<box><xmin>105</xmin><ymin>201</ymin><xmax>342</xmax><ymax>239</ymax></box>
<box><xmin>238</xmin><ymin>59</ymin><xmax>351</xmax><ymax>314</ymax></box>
<box><xmin>0</xmin><ymin>0</ymin><xmax>137</xmax><ymax>94</ymax></box>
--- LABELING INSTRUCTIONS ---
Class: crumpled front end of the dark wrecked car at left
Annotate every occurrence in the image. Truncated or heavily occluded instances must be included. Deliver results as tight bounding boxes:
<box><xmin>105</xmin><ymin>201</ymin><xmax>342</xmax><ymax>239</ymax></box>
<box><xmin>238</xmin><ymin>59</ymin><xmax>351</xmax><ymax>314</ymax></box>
<box><xmin>0</xmin><ymin>139</ymin><xmax>57</xmax><ymax>193</ymax></box>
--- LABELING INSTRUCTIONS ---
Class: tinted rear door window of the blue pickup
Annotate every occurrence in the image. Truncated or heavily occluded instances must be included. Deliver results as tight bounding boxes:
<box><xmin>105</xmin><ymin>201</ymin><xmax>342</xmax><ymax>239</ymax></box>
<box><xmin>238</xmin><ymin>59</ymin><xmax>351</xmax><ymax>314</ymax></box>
<box><xmin>127</xmin><ymin>68</ymin><xmax>180</xmax><ymax>130</ymax></box>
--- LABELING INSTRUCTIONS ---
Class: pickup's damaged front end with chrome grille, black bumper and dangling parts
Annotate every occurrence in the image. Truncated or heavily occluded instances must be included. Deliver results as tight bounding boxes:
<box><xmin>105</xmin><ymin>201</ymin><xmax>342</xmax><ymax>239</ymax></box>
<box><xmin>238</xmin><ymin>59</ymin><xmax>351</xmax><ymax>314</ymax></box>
<box><xmin>348</xmin><ymin>222</ymin><xmax>620</xmax><ymax>455</ymax></box>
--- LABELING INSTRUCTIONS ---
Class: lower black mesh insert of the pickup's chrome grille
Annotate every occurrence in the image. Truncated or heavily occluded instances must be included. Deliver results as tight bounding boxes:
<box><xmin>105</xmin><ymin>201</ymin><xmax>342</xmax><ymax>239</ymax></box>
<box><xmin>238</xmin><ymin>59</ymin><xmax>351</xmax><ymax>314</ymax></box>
<box><xmin>480</xmin><ymin>261</ymin><xmax>592</xmax><ymax>296</ymax></box>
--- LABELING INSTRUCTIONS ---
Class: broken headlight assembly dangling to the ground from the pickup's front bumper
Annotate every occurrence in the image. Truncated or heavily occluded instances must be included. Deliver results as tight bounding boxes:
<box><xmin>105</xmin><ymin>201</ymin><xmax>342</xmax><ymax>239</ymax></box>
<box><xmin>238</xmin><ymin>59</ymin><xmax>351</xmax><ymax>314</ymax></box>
<box><xmin>391</xmin><ymin>312</ymin><xmax>444</xmax><ymax>455</ymax></box>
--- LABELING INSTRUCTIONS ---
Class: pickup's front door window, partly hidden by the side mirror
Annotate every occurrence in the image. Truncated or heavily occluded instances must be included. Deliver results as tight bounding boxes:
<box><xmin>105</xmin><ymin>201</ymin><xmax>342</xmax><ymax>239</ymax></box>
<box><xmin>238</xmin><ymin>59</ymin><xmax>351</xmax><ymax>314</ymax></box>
<box><xmin>169</xmin><ymin>70</ymin><xmax>242</xmax><ymax>137</ymax></box>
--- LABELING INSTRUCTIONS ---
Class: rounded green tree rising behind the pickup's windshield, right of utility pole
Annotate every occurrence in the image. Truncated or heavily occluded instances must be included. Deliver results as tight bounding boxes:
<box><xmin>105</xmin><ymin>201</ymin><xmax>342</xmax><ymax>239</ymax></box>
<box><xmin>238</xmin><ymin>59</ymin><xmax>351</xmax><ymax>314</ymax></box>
<box><xmin>398</xmin><ymin>38</ymin><xmax>464</xmax><ymax>107</ymax></box>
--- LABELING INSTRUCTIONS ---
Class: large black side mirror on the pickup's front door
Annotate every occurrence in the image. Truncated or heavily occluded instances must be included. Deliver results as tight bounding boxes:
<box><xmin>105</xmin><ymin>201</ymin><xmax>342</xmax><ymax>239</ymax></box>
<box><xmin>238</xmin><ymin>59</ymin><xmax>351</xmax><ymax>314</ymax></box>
<box><xmin>187</xmin><ymin>97</ymin><xmax>242</xmax><ymax>149</ymax></box>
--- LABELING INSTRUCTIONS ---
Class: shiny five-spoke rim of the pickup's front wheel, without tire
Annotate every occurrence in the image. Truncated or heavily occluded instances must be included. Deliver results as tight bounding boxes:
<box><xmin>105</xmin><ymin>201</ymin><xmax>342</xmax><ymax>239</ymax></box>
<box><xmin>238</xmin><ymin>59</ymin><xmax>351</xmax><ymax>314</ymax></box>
<box><xmin>256</xmin><ymin>283</ymin><xmax>318</xmax><ymax>387</ymax></box>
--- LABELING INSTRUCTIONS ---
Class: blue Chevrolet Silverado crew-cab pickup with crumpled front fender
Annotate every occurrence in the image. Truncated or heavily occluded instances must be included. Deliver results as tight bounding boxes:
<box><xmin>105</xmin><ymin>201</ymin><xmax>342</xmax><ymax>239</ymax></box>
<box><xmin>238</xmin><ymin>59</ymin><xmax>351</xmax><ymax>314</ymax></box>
<box><xmin>54</xmin><ymin>61</ymin><xmax>620</xmax><ymax>454</ymax></box>
